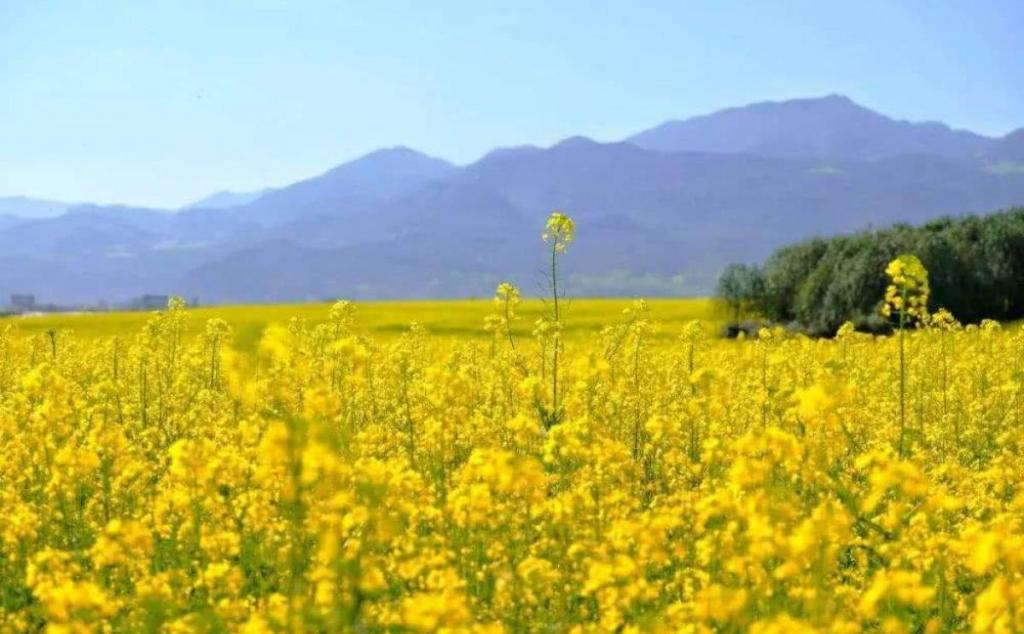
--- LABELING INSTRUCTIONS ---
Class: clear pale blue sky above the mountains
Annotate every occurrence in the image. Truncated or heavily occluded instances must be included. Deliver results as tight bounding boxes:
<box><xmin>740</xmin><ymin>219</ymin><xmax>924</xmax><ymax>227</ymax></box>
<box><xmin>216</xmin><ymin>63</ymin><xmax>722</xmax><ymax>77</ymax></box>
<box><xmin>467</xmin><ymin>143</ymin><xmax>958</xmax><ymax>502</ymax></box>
<box><xmin>0</xmin><ymin>0</ymin><xmax>1024</xmax><ymax>208</ymax></box>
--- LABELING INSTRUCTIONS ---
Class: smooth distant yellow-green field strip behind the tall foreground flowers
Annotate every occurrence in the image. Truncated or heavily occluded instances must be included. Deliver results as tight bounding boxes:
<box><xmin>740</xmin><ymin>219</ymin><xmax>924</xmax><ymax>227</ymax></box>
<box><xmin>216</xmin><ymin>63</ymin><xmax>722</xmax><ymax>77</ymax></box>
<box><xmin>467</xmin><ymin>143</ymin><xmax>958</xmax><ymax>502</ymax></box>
<box><xmin>0</xmin><ymin>298</ymin><xmax>721</xmax><ymax>351</ymax></box>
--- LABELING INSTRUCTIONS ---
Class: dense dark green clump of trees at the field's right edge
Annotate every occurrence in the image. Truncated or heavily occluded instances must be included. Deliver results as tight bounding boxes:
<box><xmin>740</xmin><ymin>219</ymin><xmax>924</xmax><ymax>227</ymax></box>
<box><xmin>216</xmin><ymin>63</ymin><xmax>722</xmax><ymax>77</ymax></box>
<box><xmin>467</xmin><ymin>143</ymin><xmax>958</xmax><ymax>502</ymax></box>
<box><xmin>717</xmin><ymin>207</ymin><xmax>1024</xmax><ymax>335</ymax></box>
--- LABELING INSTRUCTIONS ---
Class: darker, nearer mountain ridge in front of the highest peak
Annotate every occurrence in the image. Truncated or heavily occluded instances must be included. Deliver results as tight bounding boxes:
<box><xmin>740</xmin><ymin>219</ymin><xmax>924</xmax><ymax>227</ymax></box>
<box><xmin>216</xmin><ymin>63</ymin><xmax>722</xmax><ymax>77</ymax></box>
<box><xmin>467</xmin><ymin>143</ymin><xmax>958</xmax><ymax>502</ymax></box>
<box><xmin>185</xmin><ymin>139</ymin><xmax>1024</xmax><ymax>301</ymax></box>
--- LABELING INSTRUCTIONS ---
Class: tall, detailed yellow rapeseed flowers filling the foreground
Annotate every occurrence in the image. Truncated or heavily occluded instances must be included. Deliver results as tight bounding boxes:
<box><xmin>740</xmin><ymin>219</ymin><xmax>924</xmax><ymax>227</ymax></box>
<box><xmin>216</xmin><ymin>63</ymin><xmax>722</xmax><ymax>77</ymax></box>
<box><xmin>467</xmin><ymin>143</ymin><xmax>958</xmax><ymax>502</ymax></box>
<box><xmin>0</xmin><ymin>217</ymin><xmax>1024</xmax><ymax>634</ymax></box>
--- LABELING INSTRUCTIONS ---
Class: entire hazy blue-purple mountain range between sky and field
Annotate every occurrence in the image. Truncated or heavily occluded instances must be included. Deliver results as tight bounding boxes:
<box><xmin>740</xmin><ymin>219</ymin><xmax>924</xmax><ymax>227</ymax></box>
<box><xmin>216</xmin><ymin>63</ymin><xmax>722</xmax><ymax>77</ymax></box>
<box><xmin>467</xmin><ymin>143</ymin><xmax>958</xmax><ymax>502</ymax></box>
<box><xmin>0</xmin><ymin>95</ymin><xmax>1024</xmax><ymax>302</ymax></box>
